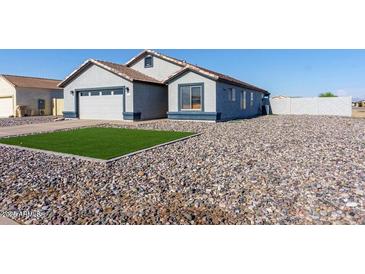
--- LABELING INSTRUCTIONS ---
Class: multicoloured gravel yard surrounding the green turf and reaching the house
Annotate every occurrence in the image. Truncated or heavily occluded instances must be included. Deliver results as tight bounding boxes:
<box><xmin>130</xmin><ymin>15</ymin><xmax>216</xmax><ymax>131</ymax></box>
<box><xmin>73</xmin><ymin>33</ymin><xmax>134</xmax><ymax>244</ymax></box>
<box><xmin>0</xmin><ymin>116</ymin><xmax>365</xmax><ymax>224</ymax></box>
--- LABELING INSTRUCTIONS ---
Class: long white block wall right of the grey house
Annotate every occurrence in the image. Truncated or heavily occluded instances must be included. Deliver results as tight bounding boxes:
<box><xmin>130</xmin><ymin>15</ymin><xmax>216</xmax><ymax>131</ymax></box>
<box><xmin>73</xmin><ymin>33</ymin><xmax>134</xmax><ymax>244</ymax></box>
<box><xmin>270</xmin><ymin>96</ymin><xmax>352</xmax><ymax>117</ymax></box>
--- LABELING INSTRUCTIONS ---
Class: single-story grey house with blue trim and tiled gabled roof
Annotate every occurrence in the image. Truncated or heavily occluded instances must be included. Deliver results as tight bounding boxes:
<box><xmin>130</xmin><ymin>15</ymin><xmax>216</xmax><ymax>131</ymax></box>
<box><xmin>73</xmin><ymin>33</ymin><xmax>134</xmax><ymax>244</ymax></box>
<box><xmin>59</xmin><ymin>50</ymin><xmax>270</xmax><ymax>121</ymax></box>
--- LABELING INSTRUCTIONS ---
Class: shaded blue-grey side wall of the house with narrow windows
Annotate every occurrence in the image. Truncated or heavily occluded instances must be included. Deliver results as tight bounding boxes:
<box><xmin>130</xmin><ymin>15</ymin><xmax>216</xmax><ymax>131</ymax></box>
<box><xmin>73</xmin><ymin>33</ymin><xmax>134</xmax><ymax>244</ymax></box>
<box><xmin>217</xmin><ymin>82</ymin><xmax>262</xmax><ymax>120</ymax></box>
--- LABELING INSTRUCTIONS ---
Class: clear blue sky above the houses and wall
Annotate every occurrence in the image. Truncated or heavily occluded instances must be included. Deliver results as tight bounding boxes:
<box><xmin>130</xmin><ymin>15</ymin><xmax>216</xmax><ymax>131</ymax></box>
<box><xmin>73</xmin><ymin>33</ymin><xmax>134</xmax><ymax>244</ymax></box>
<box><xmin>0</xmin><ymin>49</ymin><xmax>365</xmax><ymax>98</ymax></box>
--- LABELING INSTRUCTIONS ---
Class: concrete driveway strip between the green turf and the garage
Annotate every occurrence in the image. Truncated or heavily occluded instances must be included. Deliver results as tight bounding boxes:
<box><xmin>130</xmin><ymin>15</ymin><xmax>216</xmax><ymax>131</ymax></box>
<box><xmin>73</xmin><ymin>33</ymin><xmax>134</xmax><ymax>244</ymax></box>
<box><xmin>0</xmin><ymin>120</ymin><xmax>105</xmax><ymax>137</ymax></box>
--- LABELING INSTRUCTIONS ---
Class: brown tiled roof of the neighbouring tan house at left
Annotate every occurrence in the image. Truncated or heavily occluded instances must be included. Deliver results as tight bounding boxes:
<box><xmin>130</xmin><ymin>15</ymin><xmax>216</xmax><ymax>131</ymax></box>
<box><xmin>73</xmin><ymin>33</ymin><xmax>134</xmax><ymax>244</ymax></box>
<box><xmin>1</xmin><ymin>74</ymin><xmax>61</xmax><ymax>89</ymax></box>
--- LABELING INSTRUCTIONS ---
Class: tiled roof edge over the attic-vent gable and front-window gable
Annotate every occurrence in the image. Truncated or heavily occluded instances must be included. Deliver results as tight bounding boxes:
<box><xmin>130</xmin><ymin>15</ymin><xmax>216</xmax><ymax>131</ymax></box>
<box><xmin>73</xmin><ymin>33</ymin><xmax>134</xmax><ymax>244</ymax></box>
<box><xmin>126</xmin><ymin>49</ymin><xmax>270</xmax><ymax>94</ymax></box>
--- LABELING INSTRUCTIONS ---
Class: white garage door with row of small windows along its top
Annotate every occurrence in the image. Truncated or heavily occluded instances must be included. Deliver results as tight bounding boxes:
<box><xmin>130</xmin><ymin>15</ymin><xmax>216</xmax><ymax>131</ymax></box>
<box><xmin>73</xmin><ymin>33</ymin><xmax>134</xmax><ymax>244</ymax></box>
<box><xmin>79</xmin><ymin>90</ymin><xmax>124</xmax><ymax>120</ymax></box>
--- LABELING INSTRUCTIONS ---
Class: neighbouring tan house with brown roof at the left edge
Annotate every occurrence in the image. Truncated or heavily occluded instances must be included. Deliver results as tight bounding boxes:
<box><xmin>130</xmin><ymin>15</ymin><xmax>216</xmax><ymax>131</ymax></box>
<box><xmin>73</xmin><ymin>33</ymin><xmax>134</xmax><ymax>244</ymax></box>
<box><xmin>0</xmin><ymin>74</ymin><xmax>63</xmax><ymax>117</ymax></box>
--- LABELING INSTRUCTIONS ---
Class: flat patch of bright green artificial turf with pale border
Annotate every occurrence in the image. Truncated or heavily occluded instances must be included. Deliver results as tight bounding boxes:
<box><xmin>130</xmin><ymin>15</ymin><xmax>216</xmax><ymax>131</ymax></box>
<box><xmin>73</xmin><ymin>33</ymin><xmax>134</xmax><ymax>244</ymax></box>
<box><xmin>0</xmin><ymin>127</ymin><xmax>193</xmax><ymax>160</ymax></box>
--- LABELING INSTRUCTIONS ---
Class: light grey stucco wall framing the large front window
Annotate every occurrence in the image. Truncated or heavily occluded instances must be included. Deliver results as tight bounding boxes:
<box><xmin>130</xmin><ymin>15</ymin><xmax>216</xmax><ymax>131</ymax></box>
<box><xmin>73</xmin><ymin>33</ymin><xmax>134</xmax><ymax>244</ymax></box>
<box><xmin>168</xmin><ymin>71</ymin><xmax>216</xmax><ymax>112</ymax></box>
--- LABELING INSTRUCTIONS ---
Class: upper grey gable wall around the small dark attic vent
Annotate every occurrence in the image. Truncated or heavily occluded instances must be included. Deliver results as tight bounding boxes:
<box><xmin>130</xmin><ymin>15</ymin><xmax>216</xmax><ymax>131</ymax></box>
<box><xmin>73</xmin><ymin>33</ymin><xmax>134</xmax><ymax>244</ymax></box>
<box><xmin>131</xmin><ymin>56</ymin><xmax>181</xmax><ymax>81</ymax></box>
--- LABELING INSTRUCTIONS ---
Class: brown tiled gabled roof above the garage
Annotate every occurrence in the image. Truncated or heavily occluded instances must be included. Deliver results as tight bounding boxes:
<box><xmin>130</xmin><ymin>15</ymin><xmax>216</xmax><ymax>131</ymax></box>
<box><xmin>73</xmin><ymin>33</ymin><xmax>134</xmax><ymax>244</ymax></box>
<box><xmin>58</xmin><ymin>59</ymin><xmax>163</xmax><ymax>87</ymax></box>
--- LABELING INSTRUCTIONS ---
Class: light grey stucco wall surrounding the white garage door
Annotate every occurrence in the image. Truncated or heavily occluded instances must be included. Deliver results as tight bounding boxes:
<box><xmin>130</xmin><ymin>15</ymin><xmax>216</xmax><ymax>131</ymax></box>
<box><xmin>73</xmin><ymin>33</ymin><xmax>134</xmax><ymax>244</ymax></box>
<box><xmin>64</xmin><ymin>65</ymin><xmax>133</xmax><ymax>112</ymax></box>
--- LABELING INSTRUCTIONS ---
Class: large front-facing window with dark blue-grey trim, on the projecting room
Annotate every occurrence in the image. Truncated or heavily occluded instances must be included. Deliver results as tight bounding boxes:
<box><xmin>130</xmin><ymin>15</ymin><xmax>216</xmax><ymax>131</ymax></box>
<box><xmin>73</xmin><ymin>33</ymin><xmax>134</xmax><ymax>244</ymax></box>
<box><xmin>180</xmin><ymin>85</ymin><xmax>203</xmax><ymax>110</ymax></box>
